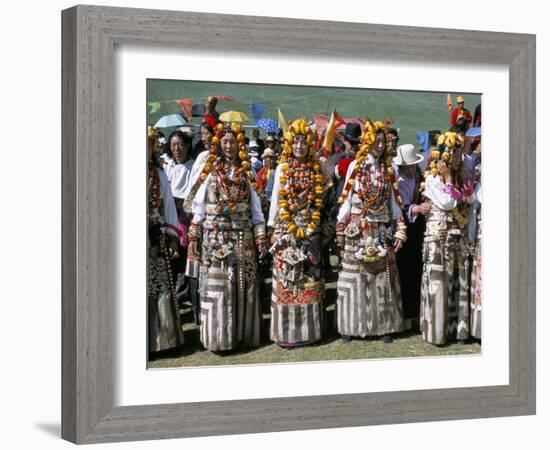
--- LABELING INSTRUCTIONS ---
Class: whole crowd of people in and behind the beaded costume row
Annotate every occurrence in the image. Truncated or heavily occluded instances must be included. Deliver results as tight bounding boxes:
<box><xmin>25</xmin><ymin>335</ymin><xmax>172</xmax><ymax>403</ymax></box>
<box><xmin>148</xmin><ymin>97</ymin><xmax>482</xmax><ymax>354</ymax></box>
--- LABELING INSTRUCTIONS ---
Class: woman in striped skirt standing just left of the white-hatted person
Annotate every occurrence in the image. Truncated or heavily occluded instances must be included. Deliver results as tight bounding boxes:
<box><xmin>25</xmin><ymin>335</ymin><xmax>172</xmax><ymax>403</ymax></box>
<box><xmin>336</xmin><ymin>120</ymin><xmax>406</xmax><ymax>342</ymax></box>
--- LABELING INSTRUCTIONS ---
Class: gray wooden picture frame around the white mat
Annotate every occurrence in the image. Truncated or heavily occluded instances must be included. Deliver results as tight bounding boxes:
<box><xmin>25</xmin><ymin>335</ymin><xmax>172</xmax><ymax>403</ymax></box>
<box><xmin>62</xmin><ymin>6</ymin><xmax>536</xmax><ymax>443</ymax></box>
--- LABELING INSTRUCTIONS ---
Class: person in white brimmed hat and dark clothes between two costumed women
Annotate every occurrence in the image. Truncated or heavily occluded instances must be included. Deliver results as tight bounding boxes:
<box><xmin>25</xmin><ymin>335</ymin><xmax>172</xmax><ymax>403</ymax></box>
<box><xmin>393</xmin><ymin>144</ymin><xmax>430</xmax><ymax>329</ymax></box>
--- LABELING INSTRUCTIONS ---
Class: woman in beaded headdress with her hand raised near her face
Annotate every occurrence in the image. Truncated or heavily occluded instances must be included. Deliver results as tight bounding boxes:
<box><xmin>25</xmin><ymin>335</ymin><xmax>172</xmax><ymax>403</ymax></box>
<box><xmin>420</xmin><ymin>132</ymin><xmax>473</xmax><ymax>345</ymax></box>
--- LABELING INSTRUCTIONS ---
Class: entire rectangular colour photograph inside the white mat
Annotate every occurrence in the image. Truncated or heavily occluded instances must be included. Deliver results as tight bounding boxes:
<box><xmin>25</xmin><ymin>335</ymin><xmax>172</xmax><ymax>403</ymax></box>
<box><xmin>143</xmin><ymin>78</ymin><xmax>482</xmax><ymax>369</ymax></box>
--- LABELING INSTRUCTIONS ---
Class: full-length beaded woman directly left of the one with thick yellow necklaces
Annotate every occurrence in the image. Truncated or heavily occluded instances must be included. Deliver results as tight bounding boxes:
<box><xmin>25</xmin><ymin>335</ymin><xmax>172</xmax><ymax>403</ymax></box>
<box><xmin>188</xmin><ymin>124</ymin><xmax>268</xmax><ymax>351</ymax></box>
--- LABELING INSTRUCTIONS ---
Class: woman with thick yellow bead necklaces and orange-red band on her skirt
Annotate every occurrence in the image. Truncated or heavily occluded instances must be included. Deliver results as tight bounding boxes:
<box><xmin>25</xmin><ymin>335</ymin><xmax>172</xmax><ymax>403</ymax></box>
<box><xmin>268</xmin><ymin>119</ymin><xmax>336</xmax><ymax>348</ymax></box>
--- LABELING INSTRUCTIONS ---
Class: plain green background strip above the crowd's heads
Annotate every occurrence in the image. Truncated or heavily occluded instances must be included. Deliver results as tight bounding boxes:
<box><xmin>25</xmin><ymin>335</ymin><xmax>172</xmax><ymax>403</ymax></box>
<box><xmin>147</xmin><ymin>80</ymin><xmax>481</xmax><ymax>144</ymax></box>
